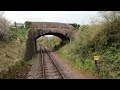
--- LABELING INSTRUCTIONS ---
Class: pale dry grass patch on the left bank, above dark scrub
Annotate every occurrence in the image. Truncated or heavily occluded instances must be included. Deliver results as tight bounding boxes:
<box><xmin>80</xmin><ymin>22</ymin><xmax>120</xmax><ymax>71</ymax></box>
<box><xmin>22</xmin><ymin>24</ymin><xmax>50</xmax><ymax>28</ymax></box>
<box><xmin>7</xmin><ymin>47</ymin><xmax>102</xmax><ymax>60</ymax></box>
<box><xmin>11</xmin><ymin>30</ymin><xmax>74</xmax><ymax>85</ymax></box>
<box><xmin>0</xmin><ymin>39</ymin><xmax>24</xmax><ymax>71</ymax></box>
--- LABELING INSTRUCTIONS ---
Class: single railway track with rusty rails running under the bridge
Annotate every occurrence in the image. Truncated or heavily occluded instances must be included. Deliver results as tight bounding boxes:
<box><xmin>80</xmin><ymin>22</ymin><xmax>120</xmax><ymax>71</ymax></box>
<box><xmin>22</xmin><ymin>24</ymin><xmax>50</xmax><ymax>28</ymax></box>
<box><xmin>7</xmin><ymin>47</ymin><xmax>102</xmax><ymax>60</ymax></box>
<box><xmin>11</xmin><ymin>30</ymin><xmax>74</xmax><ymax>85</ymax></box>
<box><xmin>39</xmin><ymin>44</ymin><xmax>65</xmax><ymax>79</ymax></box>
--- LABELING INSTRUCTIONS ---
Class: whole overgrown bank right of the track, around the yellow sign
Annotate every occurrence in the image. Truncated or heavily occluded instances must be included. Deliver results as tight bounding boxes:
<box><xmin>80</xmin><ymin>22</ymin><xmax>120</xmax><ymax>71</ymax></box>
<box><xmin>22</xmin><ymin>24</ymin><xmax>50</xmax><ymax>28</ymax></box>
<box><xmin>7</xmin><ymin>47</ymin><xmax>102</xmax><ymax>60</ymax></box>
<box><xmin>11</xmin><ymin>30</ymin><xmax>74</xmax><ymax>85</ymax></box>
<box><xmin>58</xmin><ymin>21</ymin><xmax>120</xmax><ymax>79</ymax></box>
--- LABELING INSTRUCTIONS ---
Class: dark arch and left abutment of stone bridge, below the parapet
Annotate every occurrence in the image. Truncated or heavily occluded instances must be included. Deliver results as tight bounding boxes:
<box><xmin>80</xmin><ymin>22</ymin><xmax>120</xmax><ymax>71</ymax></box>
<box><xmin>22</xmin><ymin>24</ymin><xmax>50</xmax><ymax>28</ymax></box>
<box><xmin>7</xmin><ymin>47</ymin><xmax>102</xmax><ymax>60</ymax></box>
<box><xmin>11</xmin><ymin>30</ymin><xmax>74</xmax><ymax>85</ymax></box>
<box><xmin>24</xmin><ymin>30</ymin><xmax>70</xmax><ymax>60</ymax></box>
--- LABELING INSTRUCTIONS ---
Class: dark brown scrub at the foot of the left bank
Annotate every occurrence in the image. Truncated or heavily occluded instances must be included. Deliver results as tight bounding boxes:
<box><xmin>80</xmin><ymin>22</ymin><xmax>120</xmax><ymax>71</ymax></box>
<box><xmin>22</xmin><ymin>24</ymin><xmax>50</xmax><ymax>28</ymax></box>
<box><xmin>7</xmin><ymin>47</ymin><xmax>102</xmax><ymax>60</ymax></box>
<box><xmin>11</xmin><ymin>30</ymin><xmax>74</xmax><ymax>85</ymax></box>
<box><xmin>0</xmin><ymin>60</ymin><xmax>33</xmax><ymax>79</ymax></box>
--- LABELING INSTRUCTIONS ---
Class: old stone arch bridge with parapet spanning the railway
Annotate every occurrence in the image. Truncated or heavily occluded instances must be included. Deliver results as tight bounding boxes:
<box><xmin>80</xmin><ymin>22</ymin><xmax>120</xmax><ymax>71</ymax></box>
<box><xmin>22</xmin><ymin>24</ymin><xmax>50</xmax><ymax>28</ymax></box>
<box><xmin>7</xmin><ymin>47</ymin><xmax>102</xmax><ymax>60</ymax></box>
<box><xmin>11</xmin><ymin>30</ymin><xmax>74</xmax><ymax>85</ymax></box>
<box><xmin>24</xmin><ymin>22</ymin><xmax>76</xmax><ymax>60</ymax></box>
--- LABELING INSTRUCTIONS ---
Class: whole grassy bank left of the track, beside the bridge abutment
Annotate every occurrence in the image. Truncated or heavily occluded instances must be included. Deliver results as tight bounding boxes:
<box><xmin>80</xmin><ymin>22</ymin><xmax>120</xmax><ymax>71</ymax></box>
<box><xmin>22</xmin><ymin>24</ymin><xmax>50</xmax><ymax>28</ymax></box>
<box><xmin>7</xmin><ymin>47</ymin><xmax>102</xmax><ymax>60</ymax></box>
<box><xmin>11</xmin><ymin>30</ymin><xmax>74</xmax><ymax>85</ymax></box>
<box><xmin>0</xmin><ymin>28</ymin><xmax>31</xmax><ymax>79</ymax></box>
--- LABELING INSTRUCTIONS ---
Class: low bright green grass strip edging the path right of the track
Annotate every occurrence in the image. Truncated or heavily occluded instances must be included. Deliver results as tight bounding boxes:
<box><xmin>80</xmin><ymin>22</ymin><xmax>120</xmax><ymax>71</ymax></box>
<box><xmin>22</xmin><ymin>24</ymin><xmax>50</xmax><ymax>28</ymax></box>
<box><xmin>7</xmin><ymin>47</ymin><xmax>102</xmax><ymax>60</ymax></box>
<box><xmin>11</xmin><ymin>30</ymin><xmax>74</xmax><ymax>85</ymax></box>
<box><xmin>56</xmin><ymin>44</ymin><xmax>101</xmax><ymax>78</ymax></box>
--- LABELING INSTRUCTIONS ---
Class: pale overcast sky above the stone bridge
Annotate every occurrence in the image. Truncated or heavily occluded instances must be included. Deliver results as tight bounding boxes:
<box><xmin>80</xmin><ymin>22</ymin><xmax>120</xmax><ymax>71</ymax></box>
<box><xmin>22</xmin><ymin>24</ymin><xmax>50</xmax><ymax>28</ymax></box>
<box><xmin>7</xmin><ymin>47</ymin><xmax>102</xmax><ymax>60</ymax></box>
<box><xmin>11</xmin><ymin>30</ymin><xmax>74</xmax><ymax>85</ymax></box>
<box><xmin>4</xmin><ymin>11</ymin><xmax>97</xmax><ymax>24</ymax></box>
